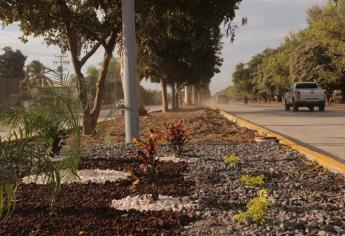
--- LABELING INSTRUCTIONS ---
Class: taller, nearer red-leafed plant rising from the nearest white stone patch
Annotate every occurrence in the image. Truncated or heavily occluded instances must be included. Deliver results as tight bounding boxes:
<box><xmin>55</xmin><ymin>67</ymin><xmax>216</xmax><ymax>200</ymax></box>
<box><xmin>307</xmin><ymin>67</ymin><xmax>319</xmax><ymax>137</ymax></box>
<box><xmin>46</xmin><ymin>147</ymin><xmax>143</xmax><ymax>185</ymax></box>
<box><xmin>133</xmin><ymin>129</ymin><xmax>162</xmax><ymax>201</ymax></box>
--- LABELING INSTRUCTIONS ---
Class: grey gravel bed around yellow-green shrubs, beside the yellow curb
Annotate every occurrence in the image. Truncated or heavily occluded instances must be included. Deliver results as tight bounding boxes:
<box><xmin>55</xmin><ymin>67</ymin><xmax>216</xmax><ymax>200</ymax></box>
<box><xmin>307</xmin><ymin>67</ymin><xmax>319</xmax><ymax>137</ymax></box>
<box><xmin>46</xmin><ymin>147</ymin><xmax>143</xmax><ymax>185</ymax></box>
<box><xmin>183</xmin><ymin>143</ymin><xmax>345</xmax><ymax>235</ymax></box>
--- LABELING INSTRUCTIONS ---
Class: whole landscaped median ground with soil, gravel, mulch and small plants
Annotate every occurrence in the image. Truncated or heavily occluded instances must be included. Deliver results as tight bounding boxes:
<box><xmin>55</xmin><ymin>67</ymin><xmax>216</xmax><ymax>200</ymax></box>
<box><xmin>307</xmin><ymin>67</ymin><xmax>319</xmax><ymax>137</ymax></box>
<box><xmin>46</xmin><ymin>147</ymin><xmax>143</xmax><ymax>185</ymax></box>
<box><xmin>0</xmin><ymin>108</ymin><xmax>345</xmax><ymax>235</ymax></box>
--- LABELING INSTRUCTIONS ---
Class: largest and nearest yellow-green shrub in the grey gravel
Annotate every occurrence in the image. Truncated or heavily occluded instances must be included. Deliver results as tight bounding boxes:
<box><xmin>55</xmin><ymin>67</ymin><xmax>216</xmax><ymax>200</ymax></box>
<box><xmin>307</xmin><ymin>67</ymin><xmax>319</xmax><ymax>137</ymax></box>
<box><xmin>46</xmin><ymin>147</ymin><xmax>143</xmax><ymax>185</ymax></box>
<box><xmin>234</xmin><ymin>189</ymin><xmax>272</xmax><ymax>224</ymax></box>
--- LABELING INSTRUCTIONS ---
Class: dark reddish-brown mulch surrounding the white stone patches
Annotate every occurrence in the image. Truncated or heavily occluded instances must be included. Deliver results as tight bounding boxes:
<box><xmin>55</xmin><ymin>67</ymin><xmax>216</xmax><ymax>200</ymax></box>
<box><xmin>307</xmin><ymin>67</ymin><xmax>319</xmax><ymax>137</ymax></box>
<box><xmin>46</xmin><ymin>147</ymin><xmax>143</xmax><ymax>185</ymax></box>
<box><xmin>0</xmin><ymin>158</ymin><xmax>193</xmax><ymax>235</ymax></box>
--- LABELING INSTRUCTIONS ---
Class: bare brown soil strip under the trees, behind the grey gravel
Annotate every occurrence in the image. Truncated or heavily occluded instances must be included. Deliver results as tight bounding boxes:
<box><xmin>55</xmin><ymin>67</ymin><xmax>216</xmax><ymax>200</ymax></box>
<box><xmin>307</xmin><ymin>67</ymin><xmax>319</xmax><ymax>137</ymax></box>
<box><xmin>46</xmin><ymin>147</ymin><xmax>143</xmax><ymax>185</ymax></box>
<box><xmin>83</xmin><ymin>108</ymin><xmax>255</xmax><ymax>144</ymax></box>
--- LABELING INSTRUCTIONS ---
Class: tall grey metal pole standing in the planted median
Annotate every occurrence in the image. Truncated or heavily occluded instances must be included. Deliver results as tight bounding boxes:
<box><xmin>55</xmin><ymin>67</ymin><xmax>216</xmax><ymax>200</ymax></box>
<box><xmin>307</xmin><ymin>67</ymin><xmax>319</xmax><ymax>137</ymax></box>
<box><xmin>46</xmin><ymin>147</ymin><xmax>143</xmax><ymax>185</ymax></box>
<box><xmin>122</xmin><ymin>0</ymin><xmax>139</xmax><ymax>143</ymax></box>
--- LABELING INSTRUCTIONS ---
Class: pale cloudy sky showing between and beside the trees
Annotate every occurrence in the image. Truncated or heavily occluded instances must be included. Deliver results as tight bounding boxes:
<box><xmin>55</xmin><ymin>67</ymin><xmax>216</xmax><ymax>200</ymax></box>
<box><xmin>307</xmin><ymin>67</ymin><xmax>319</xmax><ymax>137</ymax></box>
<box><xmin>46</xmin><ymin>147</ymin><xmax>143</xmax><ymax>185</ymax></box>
<box><xmin>0</xmin><ymin>0</ymin><xmax>327</xmax><ymax>93</ymax></box>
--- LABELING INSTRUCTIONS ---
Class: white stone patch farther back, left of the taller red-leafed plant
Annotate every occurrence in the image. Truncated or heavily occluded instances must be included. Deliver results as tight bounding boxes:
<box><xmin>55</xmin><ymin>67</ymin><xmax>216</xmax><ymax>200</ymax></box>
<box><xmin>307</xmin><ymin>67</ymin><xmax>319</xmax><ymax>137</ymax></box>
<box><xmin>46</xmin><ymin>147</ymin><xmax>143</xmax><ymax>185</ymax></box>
<box><xmin>22</xmin><ymin>169</ymin><xmax>130</xmax><ymax>184</ymax></box>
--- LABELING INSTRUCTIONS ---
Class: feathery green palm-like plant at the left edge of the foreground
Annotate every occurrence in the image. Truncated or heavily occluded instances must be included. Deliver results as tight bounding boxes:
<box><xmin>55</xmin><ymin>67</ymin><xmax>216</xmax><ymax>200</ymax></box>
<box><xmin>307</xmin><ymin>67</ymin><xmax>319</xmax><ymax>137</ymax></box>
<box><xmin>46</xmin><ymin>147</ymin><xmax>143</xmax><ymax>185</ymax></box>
<box><xmin>0</xmin><ymin>89</ymin><xmax>83</xmax><ymax>217</ymax></box>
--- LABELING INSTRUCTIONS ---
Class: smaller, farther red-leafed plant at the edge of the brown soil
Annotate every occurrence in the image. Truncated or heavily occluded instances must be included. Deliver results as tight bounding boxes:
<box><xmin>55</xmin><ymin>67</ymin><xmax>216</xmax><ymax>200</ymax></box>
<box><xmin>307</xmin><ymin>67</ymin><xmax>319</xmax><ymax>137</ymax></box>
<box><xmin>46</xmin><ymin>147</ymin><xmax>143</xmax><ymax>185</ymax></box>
<box><xmin>166</xmin><ymin>120</ymin><xmax>190</xmax><ymax>157</ymax></box>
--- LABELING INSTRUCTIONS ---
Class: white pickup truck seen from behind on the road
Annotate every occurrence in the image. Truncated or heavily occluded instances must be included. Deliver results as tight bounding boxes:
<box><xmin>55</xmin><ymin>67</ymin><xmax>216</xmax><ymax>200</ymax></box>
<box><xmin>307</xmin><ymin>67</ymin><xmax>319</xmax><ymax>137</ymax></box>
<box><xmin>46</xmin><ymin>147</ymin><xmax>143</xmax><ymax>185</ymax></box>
<box><xmin>283</xmin><ymin>82</ymin><xmax>326</xmax><ymax>112</ymax></box>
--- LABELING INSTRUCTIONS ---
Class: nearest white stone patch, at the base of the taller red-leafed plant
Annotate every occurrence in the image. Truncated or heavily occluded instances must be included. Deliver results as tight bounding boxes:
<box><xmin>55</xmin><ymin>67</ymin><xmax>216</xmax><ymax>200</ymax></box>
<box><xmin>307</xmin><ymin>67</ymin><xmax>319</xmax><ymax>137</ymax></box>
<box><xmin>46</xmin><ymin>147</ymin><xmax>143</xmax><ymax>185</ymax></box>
<box><xmin>111</xmin><ymin>194</ymin><xmax>196</xmax><ymax>212</ymax></box>
